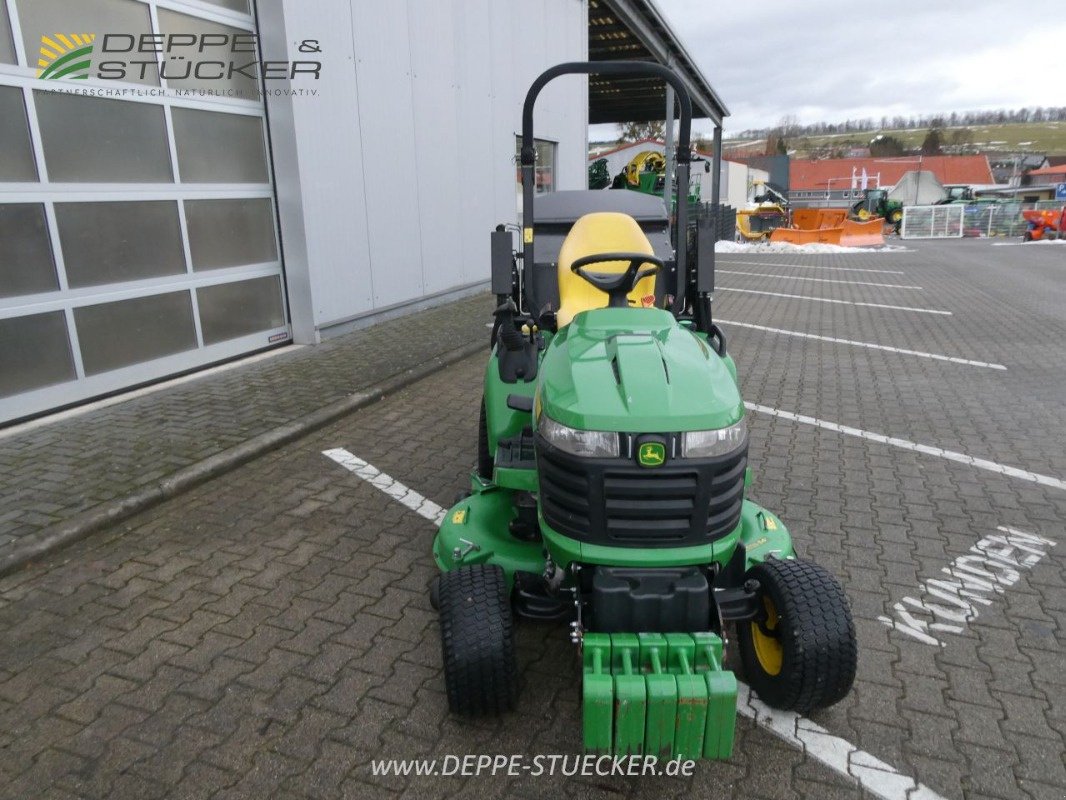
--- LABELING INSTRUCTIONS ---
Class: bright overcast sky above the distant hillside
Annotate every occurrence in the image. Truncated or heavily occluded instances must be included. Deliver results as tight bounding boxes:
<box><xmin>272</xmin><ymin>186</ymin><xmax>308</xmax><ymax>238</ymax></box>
<box><xmin>639</xmin><ymin>0</ymin><xmax>1066</xmax><ymax>135</ymax></box>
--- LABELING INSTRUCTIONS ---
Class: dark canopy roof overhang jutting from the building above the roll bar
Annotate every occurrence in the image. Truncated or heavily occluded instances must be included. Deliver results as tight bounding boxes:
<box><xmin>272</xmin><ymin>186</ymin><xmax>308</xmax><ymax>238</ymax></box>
<box><xmin>588</xmin><ymin>0</ymin><xmax>729</xmax><ymax>128</ymax></box>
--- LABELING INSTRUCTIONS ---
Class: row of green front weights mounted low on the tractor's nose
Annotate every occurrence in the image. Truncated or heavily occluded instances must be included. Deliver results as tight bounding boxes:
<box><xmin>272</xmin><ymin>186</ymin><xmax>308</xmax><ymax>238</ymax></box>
<box><xmin>582</xmin><ymin>633</ymin><xmax>737</xmax><ymax>759</ymax></box>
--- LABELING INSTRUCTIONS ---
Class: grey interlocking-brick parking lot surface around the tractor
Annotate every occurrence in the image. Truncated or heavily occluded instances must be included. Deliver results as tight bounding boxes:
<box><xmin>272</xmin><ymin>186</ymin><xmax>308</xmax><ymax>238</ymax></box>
<box><xmin>0</xmin><ymin>241</ymin><xmax>1066</xmax><ymax>800</ymax></box>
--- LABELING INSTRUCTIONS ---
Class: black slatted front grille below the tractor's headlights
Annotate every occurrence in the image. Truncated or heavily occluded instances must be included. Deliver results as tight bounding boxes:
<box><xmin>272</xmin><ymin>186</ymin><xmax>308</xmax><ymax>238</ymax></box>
<box><xmin>536</xmin><ymin>436</ymin><xmax>747</xmax><ymax>547</ymax></box>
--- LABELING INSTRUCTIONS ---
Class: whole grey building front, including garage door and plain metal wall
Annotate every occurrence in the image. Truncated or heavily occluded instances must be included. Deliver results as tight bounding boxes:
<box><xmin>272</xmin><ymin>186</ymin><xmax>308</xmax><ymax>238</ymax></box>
<box><xmin>0</xmin><ymin>0</ymin><xmax>588</xmax><ymax>423</ymax></box>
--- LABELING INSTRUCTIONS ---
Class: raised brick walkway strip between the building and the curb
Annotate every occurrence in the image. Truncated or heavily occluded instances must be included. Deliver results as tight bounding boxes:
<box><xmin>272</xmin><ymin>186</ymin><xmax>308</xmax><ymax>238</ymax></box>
<box><xmin>0</xmin><ymin>294</ymin><xmax>491</xmax><ymax>554</ymax></box>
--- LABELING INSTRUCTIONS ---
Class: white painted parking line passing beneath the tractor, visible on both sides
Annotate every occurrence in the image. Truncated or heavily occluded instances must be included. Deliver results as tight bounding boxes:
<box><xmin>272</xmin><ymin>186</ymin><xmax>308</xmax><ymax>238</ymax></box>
<box><xmin>322</xmin><ymin>447</ymin><xmax>944</xmax><ymax>800</ymax></box>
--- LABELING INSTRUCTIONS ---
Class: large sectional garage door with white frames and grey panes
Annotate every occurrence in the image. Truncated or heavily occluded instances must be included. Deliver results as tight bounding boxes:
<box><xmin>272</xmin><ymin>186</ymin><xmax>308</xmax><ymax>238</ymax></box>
<box><xmin>0</xmin><ymin>0</ymin><xmax>290</xmax><ymax>422</ymax></box>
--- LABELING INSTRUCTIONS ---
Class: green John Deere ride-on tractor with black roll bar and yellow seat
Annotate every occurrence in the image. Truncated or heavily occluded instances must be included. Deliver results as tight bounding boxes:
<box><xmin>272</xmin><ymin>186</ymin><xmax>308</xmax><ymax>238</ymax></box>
<box><xmin>431</xmin><ymin>62</ymin><xmax>856</xmax><ymax>758</ymax></box>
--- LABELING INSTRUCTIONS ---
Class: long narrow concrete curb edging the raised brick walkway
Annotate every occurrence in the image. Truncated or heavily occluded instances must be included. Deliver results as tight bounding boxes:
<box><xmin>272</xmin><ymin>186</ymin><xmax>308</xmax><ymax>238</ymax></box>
<box><xmin>0</xmin><ymin>341</ymin><xmax>486</xmax><ymax>578</ymax></box>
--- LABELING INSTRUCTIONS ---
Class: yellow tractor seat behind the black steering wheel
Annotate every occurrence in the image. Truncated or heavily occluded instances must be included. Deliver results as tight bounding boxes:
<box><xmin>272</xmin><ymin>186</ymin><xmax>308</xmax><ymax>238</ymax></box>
<box><xmin>555</xmin><ymin>211</ymin><xmax>656</xmax><ymax>327</ymax></box>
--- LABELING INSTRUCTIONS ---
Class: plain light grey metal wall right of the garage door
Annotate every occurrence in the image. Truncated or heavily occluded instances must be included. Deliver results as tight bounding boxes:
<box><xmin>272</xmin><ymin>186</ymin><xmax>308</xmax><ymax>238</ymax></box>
<box><xmin>259</xmin><ymin>0</ymin><xmax>587</xmax><ymax>342</ymax></box>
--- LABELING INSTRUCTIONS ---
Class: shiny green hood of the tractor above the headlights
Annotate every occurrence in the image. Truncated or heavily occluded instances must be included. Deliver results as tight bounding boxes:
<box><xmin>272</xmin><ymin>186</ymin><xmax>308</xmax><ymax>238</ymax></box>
<box><xmin>539</xmin><ymin>308</ymin><xmax>744</xmax><ymax>433</ymax></box>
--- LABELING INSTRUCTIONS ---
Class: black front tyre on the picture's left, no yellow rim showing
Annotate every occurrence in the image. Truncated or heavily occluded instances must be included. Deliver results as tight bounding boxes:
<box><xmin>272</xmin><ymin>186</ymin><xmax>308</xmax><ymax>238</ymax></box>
<box><xmin>438</xmin><ymin>564</ymin><xmax>518</xmax><ymax>716</ymax></box>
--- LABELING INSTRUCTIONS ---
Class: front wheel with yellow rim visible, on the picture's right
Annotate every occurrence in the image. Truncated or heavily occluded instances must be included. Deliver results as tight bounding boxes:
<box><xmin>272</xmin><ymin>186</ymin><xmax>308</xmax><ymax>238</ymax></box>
<box><xmin>737</xmin><ymin>559</ymin><xmax>858</xmax><ymax>714</ymax></box>
